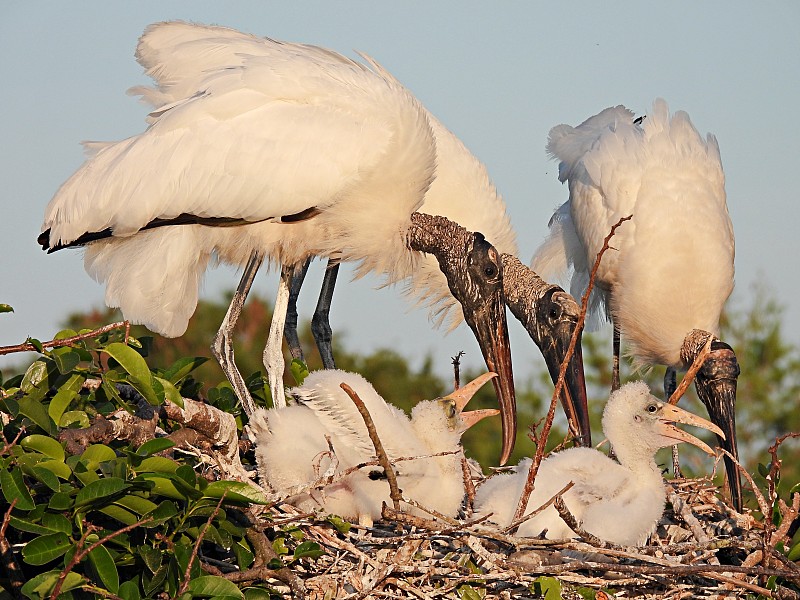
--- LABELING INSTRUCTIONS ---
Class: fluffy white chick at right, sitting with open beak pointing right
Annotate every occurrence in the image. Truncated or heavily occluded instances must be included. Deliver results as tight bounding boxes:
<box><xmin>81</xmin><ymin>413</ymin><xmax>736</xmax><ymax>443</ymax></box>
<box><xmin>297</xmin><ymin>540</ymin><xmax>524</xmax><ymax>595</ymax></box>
<box><xmin>475</xmin><ymin>381</ymin><xmax>723</xmax><ymax>546</ymax></box>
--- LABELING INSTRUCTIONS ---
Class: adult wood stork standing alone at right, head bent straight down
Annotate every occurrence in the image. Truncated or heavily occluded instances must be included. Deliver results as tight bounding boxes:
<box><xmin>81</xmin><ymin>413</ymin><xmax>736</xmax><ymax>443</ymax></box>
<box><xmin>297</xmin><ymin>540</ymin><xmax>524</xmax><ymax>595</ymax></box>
<box><xmin>532</xmin><ymin>99</ymin><xmax>741</xmax><ymax>510</ymax></box>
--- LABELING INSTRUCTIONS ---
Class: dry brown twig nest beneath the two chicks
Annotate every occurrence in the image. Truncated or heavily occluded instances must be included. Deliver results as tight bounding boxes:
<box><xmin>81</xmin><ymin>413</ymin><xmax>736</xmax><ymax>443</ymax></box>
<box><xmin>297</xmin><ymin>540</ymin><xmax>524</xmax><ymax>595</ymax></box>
<box><xmin>258</xmin><ymin>479</ymin><xmax>800</xmax><ymax>600</ymax></box>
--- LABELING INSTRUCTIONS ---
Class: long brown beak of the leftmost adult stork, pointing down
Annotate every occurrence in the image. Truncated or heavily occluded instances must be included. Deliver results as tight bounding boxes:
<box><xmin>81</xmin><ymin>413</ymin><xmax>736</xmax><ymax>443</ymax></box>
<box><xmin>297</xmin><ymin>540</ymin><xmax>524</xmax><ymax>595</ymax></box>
<box><xmin>462</xmin><ymin>298</ymin><xmax>517</xmax><ymax>465</ymax></box>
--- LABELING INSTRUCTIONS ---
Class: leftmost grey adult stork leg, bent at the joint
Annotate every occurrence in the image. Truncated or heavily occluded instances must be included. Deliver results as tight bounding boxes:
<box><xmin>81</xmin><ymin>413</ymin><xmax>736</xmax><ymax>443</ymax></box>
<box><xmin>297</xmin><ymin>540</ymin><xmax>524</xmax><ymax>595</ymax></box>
<box><xmin>211</xmin><ymin>252</ymin><xmax>264</xmax><ymax>417</ymax></box>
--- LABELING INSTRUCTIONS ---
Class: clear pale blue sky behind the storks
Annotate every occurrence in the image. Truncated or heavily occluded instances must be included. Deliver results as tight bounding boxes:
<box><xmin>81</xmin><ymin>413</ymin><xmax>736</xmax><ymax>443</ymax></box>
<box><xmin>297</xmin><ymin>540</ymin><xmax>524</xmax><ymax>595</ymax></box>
<box><xmin>0</xmin><ymin>0</ymin><xmax>800</xmax><ymax>379</ymax></box>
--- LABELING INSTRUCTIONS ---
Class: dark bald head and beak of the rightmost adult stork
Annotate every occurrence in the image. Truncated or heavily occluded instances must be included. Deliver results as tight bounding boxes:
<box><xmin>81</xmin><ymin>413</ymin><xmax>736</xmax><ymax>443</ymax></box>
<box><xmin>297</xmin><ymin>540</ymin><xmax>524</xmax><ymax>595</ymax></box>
<box><xmin>694</xmin><ymin>341</ymin><xmax>742</xmax><ymax>512</ymax></box>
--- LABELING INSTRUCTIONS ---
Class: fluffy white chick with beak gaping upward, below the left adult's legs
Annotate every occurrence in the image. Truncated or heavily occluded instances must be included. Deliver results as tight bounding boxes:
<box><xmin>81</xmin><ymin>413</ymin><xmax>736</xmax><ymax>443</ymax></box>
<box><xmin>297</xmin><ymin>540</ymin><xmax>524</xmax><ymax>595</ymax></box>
<box><xmin>250</xmin><ymin>369</ymin><xmax>498</xmax><ymax>524</ymax></box>
